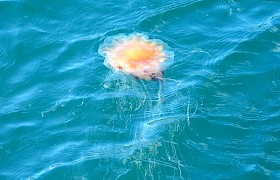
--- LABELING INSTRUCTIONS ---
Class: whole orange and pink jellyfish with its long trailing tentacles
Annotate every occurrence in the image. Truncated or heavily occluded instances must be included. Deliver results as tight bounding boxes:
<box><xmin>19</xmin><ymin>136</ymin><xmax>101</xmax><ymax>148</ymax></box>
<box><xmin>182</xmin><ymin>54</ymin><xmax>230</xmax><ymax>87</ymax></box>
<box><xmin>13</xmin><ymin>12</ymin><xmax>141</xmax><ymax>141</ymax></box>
<box><xmin>97</xmin><ymin>33</ymin><xmax>191</xmax><ymax>179</ymax></box>
